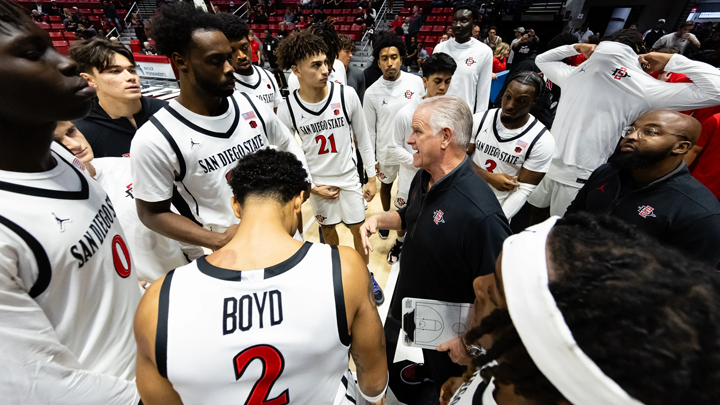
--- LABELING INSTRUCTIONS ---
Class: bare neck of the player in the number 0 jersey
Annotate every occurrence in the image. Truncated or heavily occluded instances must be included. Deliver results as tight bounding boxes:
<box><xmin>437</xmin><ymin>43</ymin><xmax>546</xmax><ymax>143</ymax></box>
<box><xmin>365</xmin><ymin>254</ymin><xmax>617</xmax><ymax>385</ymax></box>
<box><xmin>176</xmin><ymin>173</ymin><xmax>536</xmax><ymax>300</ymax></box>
<box><xmin>0</xmin><ymin>122</ymin><xmax>57</xmax><ymax>173</ymax></box>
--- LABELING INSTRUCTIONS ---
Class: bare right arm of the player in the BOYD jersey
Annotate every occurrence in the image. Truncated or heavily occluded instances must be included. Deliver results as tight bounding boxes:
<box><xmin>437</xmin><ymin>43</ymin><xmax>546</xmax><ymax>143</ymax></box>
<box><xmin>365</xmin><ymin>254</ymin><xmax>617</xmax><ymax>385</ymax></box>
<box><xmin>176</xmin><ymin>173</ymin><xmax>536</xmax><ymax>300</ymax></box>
<box><xmin>339</xmin><ymin>246</ymin><xmax>388</xmax><ymax>404</ymax></box>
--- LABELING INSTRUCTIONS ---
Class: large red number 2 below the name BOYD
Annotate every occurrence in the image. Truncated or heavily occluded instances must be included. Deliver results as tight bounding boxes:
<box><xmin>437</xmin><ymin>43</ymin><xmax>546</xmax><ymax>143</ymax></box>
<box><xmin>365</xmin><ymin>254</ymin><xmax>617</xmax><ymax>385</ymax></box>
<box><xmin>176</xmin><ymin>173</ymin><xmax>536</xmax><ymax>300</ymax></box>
<box><xmin>233</xmin><ymin>345</ymin><xmax>290</xmax><ymax>405</ymax></box>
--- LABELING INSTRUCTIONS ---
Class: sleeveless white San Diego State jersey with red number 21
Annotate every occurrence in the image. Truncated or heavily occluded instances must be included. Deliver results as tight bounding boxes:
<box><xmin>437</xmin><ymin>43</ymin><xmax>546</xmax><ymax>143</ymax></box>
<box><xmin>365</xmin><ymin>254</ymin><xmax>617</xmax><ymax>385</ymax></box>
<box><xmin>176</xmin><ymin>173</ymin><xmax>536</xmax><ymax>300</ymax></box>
<box><xmin>278</xmin><ymin>82</ymin><xmax>357</xmax><ymax>186</ymax></box>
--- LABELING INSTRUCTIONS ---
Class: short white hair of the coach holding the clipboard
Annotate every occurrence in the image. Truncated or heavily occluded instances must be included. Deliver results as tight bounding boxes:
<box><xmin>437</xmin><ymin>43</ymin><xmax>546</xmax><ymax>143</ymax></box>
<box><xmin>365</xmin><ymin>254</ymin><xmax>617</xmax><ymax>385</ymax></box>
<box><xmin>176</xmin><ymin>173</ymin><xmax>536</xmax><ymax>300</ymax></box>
<box><xmin>418</xmin><ymin>96</ymin><xmax>473</xmax><ymax>151</ymax></box>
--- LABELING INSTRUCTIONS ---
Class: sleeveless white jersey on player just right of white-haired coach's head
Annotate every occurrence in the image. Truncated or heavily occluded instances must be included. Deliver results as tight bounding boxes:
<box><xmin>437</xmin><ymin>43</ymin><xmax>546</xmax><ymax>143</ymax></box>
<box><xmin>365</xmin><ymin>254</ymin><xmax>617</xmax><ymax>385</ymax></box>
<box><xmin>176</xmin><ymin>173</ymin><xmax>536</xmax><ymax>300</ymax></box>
<box><xmin>471</xmin><ymin>108</ymin><xmax>549</xmax><ymax>203</ymax></box>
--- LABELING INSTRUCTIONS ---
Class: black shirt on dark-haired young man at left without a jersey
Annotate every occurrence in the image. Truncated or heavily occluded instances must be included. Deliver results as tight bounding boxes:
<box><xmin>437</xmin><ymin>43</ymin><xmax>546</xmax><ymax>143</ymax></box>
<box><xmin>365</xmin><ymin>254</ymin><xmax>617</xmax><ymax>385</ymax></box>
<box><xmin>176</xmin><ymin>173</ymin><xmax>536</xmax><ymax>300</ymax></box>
<box><xmin>73</xmin><ymin>97</ymin><xmax>167</xmax><ymax>158</ymax></box>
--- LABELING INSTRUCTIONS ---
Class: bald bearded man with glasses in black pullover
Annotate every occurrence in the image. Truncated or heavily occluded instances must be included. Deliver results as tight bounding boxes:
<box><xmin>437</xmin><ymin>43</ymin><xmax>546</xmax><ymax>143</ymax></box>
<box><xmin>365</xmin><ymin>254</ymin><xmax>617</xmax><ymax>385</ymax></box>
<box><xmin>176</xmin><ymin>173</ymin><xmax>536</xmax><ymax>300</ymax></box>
<box><xmin>566</xmin><ymin>110</ymin><xmax>720</xmax><ymax>266</ymax></box>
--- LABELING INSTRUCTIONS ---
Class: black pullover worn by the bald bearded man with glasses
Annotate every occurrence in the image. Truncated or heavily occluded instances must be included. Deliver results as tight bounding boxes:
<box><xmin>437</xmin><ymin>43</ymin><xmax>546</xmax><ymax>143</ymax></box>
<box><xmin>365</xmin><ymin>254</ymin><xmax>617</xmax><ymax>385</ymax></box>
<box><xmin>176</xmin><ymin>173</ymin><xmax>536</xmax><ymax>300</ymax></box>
<box><xmin>568</xmin><ymin>163</ymin><xmax>720</xmax><ymax>266</ymax></box>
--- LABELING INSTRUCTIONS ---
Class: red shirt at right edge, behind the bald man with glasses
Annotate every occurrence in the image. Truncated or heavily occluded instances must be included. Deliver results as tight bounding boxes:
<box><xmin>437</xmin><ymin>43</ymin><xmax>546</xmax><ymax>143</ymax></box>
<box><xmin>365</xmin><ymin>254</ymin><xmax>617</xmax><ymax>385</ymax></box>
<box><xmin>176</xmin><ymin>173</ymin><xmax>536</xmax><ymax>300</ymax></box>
<box><xmin>690</xmin><ymin>114</ymin><xmax>720</xmax><ymax>198</ymax></box>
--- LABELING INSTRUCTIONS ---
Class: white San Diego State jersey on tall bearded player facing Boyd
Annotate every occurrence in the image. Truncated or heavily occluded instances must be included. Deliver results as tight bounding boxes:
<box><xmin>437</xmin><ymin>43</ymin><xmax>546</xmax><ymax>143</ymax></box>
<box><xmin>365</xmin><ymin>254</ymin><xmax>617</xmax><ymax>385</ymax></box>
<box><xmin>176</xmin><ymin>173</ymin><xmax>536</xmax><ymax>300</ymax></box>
<box><xmin>131</xmin><ymin>92</ymin><xmax>271</xmax><ymax>231</ymax></box>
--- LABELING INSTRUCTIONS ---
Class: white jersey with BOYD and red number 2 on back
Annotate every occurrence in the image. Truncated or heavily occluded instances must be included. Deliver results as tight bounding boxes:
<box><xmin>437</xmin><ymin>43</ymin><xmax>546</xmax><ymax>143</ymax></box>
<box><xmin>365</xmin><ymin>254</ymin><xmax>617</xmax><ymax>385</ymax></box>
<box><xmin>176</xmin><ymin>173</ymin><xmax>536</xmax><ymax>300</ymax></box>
<box><xmin>155</xmin><ymin>242</ymin><xmax>350</xmax><ymax>405</ymax></box>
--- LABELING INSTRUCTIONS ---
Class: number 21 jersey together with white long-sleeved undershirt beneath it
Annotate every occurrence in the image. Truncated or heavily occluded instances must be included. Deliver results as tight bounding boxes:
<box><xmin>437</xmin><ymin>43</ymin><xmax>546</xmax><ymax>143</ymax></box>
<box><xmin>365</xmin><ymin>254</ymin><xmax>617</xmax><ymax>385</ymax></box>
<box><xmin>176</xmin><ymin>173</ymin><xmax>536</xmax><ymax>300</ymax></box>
<box><xmin>277</xmin><ymin>82</ymin><xmax>375</xmax><ymax>187</ymax></box>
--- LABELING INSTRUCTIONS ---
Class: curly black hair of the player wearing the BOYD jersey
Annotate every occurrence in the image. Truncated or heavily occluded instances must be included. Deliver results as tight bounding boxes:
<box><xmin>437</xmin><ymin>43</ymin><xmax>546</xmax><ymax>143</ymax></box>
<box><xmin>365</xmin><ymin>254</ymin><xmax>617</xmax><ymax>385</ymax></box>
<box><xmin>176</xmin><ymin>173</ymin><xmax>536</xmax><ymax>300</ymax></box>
<box><xmin>228</xmin><ymin>148</ymin><xmax>309</xmax><ymax>205</ymax></box>
